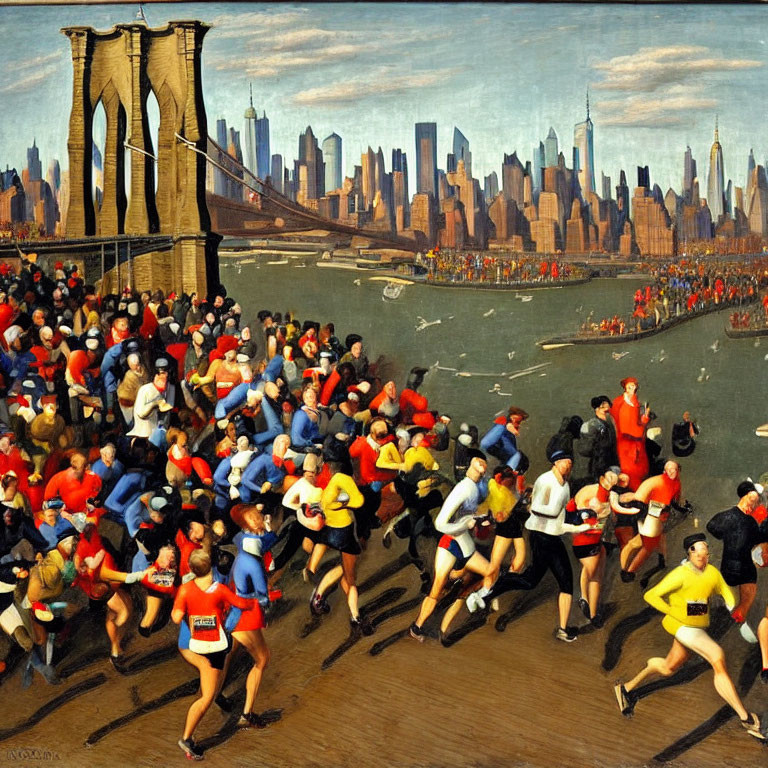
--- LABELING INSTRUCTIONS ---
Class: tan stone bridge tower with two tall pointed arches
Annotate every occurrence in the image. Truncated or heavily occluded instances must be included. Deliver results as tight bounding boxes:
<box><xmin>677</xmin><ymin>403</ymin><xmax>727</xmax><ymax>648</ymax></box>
<box><xmin>62</xmin><ymin>21</ymin><xmax>220</xmax><ymax>293</ymax></box>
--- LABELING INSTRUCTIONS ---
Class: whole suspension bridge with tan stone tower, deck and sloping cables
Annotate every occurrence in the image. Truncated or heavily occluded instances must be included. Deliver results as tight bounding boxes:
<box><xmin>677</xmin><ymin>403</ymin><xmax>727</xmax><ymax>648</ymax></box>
<box><xmin>0</xmin><ymin>20</ymin><xmax>420</xmax><ymax>293</ymax></box>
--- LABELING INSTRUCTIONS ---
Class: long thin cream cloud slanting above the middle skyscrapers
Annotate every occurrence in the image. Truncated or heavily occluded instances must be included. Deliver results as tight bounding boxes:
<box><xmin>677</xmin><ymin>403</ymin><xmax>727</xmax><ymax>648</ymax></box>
<box><xmin>291</xmin><ymin>69</ymin><xmax>457</xmax><ymax>107</ymax></box>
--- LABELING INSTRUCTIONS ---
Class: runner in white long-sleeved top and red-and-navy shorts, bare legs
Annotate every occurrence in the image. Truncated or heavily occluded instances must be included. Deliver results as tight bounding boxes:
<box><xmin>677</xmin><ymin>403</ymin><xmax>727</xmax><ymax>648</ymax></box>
<box><xmin>410</xmin><ymin>451</ymin><xmax>491</xmax><ymax>642</ymax></box>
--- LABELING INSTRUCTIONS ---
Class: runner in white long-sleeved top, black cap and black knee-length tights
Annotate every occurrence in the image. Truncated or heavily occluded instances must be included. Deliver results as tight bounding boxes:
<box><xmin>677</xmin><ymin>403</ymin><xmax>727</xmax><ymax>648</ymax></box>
<box><xmin>474</xmin><ymin>448</ymin><xmax>592</xmax><ymax>643</ymax></box>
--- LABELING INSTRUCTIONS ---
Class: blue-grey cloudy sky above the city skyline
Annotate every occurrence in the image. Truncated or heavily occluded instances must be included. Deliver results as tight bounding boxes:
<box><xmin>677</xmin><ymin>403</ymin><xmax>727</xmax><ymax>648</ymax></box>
<box><xmin>0</xmin><ymin>2</ymin><xmax>768</xmax><ymax>194</ymax></box>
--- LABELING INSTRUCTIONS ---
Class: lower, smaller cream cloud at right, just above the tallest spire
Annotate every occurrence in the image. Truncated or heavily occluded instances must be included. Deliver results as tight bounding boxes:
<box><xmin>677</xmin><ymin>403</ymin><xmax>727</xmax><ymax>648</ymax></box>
<box><xmin>595</xmin><ymin>86</ymin><xmax>718</xmax><ymax>128</ymax></box>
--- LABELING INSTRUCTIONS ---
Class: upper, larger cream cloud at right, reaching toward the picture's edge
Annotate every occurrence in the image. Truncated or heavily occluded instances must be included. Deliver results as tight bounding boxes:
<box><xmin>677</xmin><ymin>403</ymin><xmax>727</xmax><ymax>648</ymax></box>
<box><xmin>592</xmin><ymin>45</ymin><xmax>763</xmax><ymax>93</ymax></box>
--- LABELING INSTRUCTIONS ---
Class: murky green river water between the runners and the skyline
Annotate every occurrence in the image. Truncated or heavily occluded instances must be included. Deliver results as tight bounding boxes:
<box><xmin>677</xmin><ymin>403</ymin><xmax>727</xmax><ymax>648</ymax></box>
<box><xmin>221</xmin><ymin>259</ymin><xmax>768</xmax><ymax>519</ymax></box>
